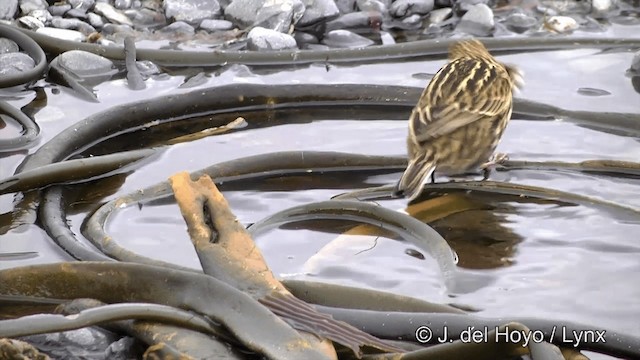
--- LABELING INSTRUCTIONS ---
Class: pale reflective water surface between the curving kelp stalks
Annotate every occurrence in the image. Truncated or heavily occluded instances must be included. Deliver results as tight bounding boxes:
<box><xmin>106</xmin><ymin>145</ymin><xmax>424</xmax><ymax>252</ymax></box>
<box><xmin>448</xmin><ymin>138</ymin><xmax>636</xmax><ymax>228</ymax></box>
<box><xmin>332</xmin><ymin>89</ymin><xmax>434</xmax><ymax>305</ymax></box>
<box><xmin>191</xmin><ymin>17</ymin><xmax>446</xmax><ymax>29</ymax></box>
<box><xmin>0</xmin><ymin>26</ymin><xmax>640</xmax><ymax>358</ymax></box>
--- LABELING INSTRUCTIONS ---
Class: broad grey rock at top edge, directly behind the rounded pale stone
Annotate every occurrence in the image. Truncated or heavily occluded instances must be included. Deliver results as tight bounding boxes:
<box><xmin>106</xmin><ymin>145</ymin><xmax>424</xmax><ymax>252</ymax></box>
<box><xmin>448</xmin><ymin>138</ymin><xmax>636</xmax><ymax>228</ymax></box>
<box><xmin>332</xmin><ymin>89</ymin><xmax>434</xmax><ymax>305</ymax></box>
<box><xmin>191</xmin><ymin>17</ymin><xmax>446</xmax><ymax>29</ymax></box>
<box><xmin>224</xmin><ymin>0</ymin><xmax>304</xmax><ymax>32</ymax></box>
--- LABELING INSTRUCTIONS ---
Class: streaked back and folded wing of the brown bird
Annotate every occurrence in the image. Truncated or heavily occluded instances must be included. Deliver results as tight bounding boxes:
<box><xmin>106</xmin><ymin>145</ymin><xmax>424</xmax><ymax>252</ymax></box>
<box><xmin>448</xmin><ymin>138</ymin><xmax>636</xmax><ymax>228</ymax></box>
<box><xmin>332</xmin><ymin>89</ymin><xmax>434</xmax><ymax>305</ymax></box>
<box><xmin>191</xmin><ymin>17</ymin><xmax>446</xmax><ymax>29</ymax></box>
<box><xmin>410</xmin><ymin>59</ymin><xmax>512</xmax><ymax>143</ymax></box>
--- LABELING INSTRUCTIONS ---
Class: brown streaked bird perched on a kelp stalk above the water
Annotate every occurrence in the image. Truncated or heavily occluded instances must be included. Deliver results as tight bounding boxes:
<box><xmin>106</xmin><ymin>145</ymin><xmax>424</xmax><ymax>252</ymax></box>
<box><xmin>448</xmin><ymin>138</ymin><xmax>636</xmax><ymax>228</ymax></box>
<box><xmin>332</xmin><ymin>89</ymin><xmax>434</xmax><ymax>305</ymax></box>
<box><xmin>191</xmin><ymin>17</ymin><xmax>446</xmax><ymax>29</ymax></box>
<box><xmin>395</xmin><ymin>39</ymin><xmax>524</xmax><ymax>201</ymax></box>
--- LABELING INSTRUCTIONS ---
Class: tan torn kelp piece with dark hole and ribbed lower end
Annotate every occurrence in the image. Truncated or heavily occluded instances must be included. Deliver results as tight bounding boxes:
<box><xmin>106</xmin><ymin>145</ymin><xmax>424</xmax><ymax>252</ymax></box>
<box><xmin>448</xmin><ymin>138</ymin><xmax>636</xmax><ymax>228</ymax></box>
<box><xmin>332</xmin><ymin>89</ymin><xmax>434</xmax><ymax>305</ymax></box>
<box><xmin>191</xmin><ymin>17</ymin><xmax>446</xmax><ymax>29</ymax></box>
<box><xmin>170</xmin><ymin>172</ymin><xmax>400</xmax><ymax>356</ymax></box>
